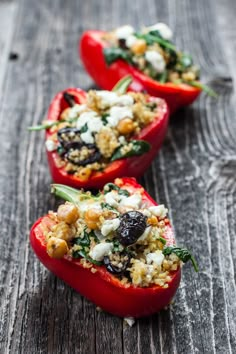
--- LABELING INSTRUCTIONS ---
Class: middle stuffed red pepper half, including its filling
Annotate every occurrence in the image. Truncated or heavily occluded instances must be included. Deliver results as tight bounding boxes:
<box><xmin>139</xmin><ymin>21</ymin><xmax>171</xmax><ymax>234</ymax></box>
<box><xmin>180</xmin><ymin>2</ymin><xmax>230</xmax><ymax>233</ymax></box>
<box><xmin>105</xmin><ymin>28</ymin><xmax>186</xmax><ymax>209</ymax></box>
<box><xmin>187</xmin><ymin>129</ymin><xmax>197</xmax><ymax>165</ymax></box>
<box><xmin>30</xmin><ymin>78</ymin><xmax>169</xmax><ymax>188</ymax></box>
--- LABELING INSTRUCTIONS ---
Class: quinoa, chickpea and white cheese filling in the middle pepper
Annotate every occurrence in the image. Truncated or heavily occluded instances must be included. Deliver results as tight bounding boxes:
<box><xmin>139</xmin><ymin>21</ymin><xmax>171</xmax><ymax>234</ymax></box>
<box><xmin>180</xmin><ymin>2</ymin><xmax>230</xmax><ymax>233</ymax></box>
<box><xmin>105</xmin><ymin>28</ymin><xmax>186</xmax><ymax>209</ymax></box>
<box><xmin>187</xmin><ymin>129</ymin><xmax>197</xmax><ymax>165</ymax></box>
<box><xmin>43</xmin><ymin>90</ymin><xmax>160</xmax><ymax>181</ymax></box>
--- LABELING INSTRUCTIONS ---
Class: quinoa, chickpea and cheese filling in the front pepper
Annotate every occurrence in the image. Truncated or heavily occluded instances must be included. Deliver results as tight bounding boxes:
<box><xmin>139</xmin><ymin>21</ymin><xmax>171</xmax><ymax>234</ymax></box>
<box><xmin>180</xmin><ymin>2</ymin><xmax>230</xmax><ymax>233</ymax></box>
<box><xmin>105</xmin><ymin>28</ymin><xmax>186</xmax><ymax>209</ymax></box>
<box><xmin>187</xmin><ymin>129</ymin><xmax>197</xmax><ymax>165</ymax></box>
<box><xmin>44</xmin><ymin>183</ymin><xmax>185</xmax><ymax>288</ymax></box>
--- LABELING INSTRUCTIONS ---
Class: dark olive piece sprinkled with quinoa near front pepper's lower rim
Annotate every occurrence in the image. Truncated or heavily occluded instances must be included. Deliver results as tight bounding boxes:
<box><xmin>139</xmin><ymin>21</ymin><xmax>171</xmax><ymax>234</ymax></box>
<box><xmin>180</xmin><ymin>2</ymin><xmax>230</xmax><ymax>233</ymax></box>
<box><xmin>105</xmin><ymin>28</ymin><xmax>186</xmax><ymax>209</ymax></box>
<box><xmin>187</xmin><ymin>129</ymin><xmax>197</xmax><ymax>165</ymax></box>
<box><xmin>103</xmin><ymin>252</ymin><xmax>130</xmax><ymax>275</ymax></box>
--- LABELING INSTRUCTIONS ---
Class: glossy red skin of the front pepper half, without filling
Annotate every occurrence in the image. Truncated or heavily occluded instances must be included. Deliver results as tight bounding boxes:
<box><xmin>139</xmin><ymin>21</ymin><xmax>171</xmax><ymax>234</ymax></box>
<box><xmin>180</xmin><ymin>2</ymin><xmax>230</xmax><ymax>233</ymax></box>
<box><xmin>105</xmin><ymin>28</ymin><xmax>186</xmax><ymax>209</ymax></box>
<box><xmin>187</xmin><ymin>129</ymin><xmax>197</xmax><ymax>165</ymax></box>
<box><xmin>30</xmin><ymin>178</ymin><xmax>181</xmax><ymax>317</ymax></box>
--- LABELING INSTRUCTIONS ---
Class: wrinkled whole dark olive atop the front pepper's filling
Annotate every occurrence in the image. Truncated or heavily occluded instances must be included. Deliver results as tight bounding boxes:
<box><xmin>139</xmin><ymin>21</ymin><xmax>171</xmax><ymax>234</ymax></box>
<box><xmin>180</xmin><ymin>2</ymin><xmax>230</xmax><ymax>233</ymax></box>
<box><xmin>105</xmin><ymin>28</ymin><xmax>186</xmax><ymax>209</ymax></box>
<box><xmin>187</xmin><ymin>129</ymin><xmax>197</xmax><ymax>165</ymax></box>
<box><xmin>117</xmin><ymin>211</ymin><xmax>147</xmax><ymax>246</ymax></box>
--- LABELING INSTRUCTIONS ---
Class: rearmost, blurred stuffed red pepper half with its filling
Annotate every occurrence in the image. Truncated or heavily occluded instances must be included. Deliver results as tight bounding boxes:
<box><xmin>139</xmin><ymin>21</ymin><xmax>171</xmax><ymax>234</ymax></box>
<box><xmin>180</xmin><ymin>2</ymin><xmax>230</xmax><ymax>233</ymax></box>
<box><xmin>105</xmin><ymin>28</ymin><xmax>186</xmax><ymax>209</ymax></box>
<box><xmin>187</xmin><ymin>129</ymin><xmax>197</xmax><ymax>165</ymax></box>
<box><xmin>79</xmin><ymin>23</ymin><xmax>215</xmax><ymax>112</ymax></box>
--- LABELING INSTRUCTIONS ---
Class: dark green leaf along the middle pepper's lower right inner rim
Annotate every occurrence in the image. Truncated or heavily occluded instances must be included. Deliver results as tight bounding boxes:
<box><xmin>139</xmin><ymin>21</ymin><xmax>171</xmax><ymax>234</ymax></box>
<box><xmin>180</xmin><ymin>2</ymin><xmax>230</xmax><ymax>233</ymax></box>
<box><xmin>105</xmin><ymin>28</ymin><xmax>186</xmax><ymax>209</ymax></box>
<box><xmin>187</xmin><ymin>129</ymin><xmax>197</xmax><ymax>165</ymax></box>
<box><xmin>111</xmin><ymin>140</ymin><xmax>151</xmax><ymax>161</ymax></box>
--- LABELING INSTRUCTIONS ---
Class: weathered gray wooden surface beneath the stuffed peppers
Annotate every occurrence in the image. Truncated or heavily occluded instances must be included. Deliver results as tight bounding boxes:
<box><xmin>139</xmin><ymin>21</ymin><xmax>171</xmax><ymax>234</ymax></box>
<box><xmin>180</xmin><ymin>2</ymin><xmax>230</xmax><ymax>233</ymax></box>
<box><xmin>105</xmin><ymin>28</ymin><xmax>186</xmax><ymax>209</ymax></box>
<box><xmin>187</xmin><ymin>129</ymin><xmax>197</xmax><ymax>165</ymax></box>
<box><xmin>0</xmin><ymin>0</ymin><xmax>236</xmax><ymax>354</ymax></box>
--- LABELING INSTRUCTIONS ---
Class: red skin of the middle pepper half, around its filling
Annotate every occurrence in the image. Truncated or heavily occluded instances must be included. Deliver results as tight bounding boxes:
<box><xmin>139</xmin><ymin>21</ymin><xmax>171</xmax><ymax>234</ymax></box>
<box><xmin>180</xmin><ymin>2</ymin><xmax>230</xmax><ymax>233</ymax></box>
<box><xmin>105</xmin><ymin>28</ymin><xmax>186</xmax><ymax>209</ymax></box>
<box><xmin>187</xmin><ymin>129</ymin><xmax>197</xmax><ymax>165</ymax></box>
<box><xmin>46</xmin><ymin>88</ymin><xmax>169</xmax><ymax>188</ymax></box>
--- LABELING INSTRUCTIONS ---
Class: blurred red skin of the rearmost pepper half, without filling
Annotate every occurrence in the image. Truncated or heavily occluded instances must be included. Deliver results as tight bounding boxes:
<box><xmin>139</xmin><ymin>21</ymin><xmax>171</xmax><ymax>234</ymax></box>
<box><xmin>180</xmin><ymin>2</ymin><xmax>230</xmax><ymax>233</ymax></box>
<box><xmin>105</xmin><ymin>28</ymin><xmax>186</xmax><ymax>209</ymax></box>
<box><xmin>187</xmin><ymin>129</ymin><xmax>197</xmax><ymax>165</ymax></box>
<box><xmin>79</xmin><ymin>31</ymin><xmax>201</xmax><ymax>113</ymax></box>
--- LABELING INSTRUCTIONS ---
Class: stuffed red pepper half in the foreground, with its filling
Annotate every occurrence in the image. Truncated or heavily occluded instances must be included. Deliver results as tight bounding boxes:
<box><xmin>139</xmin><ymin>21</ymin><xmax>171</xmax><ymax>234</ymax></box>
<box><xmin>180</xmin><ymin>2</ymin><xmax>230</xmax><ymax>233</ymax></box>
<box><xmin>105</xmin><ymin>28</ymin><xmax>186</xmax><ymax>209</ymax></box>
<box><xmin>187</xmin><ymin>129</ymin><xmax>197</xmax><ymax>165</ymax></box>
<box><xmin>30</xmin><ymin>178</ymin><xmax>197</xmax><ymax>317</ymax></box>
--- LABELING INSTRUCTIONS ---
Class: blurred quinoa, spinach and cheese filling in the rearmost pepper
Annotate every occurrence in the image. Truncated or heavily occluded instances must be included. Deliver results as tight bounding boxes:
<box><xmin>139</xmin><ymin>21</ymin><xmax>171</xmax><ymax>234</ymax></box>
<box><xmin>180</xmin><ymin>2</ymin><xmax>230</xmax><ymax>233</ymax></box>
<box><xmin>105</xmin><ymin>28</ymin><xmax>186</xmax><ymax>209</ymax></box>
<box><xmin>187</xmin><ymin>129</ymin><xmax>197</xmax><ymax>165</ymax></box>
<box><xmin>103</xmin><ymin>23</ymin><xmax>204</xmax><ymax>89</ymax></box>
